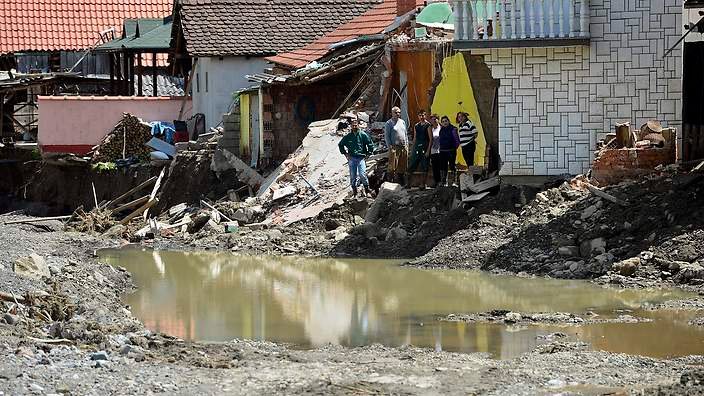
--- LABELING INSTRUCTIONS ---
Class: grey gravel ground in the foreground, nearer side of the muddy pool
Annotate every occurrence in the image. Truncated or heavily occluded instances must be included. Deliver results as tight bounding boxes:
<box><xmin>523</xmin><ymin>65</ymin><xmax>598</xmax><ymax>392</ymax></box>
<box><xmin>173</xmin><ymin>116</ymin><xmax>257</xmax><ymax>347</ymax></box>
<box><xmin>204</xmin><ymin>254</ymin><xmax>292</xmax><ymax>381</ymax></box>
<box><xmin>0</xmin><ymin>216</ymin><xmax>704</xmax><ymax>395</ymax></box>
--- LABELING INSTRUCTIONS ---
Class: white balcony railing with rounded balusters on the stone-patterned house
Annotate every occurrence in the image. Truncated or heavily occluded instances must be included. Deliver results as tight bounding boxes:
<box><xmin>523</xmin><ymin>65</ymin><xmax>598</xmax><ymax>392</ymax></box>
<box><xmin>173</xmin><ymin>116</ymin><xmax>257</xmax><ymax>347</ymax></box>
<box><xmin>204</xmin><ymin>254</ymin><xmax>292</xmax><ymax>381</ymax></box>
<box><xmin>452</xmin><ymin>0</ymin><xmax>589</xmax><ymax>47</ymax></box>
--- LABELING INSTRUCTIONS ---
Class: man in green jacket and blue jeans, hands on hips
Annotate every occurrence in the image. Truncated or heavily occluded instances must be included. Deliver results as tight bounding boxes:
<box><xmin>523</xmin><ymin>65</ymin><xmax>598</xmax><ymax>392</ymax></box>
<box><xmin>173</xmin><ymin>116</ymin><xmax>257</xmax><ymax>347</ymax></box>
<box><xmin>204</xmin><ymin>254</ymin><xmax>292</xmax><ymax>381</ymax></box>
<box><xmin>338</xmin><ymin>118</ymin><xmax>374</xmax><ymax>197</ymax></box>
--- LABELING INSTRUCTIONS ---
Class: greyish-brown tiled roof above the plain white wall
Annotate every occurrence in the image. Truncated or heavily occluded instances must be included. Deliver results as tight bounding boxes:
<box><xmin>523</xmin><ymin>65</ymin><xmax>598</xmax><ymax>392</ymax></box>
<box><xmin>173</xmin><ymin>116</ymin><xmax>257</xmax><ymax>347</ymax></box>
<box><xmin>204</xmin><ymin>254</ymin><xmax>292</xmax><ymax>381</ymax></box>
<box><xmin>180</xmin><ymin>0</ymin><xmax>382</xmax><ymax>56</ymax></box>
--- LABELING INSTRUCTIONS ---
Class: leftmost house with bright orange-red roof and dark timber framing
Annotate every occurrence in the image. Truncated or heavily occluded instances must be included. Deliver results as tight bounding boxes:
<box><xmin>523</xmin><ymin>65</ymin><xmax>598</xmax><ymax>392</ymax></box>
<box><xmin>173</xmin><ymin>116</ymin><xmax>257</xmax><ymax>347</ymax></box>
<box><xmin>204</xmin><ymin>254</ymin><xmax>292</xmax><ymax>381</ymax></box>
<box><xmin>0</xmin><ymin>0</ymin><xmax>172</xmax><ymax>140</ymax></box>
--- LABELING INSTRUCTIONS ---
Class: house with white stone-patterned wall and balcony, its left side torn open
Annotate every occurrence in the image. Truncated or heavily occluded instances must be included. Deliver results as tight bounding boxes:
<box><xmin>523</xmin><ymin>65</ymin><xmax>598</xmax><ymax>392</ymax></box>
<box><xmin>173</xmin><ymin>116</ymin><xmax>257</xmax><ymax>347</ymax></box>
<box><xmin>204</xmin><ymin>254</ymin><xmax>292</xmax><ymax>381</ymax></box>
<box><xmin>446</xmin><ymin>0</ymin><xmax>682</xmax><ymax>176</ymax></box>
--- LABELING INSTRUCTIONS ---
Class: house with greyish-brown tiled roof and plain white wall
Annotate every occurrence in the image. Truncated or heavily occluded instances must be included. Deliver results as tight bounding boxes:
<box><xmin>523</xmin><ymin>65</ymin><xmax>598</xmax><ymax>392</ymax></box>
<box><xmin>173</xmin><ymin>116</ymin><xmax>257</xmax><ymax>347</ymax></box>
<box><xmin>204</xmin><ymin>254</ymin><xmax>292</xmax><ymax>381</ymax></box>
<box><xmin>172</xmin><ymin>0</ymin><xmax>388</xmax><ymax>128</ymax></box>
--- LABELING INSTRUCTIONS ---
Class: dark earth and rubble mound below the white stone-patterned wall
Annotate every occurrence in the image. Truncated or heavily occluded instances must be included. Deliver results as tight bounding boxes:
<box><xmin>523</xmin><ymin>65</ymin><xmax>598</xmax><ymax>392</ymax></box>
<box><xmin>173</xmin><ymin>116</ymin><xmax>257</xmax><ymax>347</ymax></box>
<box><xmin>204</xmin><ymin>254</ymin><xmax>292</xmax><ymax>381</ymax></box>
<box><xmin>414</xmin><ymin>169</ymin><xmax>704</xmax><ymax>284</ymax></box>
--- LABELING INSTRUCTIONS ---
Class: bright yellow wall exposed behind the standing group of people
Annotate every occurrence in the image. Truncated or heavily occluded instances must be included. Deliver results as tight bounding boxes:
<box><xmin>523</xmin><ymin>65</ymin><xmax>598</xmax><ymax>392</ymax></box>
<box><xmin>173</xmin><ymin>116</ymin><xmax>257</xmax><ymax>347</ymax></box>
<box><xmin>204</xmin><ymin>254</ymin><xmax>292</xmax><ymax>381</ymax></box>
<box><xmin>431</xmin><ymin>53</ymin><xmax>486</xmax><ymax>166</ymax></box>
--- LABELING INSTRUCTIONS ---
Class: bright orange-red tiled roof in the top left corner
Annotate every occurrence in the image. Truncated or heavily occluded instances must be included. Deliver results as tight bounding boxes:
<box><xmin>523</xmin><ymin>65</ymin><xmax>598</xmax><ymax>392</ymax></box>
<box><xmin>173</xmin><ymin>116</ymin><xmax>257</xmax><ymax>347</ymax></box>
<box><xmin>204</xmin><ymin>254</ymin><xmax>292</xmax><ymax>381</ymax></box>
<box><xmin>0</xmin><ymin>0</ymin><xmax>173</xmax><ymax>54</ymax></box>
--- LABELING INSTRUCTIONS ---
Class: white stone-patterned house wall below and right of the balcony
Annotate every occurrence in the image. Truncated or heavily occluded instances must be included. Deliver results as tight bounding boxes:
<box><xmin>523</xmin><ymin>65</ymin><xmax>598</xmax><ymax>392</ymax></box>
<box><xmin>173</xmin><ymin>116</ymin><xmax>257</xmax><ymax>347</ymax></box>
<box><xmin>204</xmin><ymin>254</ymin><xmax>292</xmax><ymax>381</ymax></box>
<box><xmin>472</xmin><ymin>0</ymin><xmax>683</xmax><ymax>175</ymax></box>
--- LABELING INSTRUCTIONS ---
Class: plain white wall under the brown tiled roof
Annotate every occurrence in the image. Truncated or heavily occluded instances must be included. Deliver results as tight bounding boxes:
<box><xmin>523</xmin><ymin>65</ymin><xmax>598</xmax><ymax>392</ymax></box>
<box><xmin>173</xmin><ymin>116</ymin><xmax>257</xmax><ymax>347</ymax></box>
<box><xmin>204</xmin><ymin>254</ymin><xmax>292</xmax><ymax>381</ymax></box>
<box><xmin>191</xmin><ymin>56</ymin><xmax>267</xmax><ymax>129</ymax></box>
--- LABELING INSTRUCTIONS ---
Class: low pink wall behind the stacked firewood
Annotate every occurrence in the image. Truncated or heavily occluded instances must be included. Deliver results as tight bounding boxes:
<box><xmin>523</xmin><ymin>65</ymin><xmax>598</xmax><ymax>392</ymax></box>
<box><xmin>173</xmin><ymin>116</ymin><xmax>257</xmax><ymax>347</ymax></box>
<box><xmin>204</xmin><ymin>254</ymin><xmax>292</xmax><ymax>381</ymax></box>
<box><xmin>38</xmin><ymin>96</ymin><xmax>193</xmax><ymax>155</ymax></box>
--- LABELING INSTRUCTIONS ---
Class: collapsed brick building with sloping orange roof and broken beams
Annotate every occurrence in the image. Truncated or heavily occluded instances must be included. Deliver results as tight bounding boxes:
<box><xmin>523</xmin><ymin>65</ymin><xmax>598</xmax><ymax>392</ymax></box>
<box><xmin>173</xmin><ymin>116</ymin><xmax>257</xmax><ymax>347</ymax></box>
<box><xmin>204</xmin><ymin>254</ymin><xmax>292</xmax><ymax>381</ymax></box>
<box><xmin>235</xmin><ymin>0</ymin><xmax>422</xmax><ymax>165</ymax></box>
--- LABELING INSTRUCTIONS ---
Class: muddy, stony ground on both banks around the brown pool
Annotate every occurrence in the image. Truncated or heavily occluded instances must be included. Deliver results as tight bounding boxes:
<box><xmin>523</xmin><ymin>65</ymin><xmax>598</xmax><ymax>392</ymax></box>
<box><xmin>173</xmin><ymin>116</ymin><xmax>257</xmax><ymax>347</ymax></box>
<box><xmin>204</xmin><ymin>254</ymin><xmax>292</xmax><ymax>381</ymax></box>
<box><xmin>0</xmin><ymin>169</ymin><xmax>704</xmax><ymax>394</ymax></box>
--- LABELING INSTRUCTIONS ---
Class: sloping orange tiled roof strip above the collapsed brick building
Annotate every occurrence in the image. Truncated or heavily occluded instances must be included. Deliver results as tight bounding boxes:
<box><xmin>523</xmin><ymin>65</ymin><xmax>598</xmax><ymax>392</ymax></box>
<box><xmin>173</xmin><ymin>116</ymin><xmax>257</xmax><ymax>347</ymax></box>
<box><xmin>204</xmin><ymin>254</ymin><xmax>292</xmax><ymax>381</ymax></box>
<box><xmin>267</xmin><ymin>0</ymin><xmax>424</xmax><ymax>69</ymax></box>
